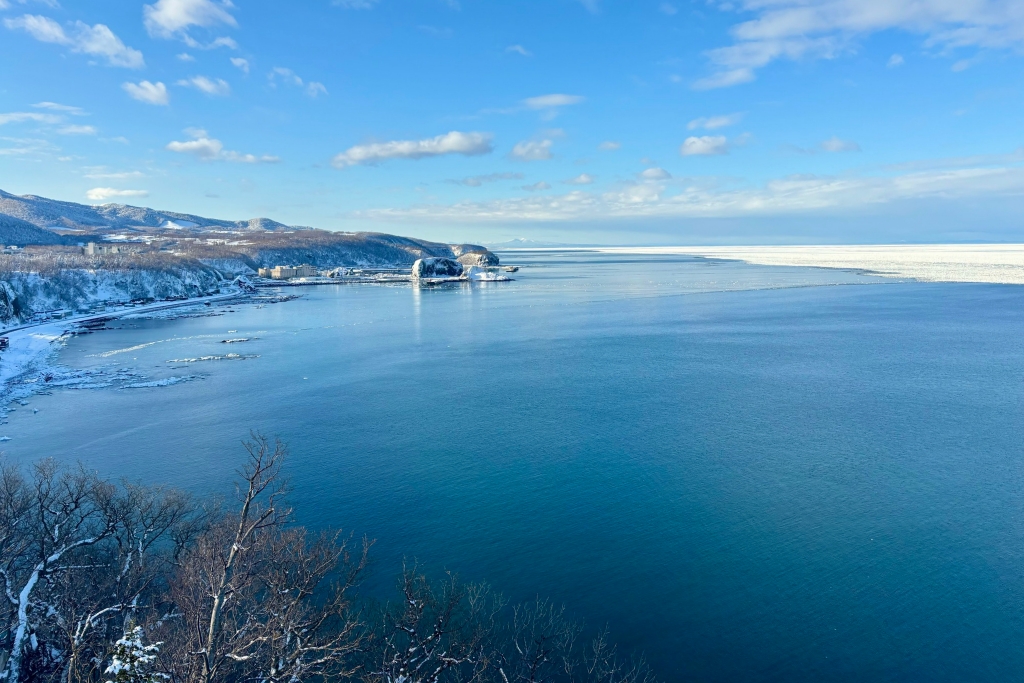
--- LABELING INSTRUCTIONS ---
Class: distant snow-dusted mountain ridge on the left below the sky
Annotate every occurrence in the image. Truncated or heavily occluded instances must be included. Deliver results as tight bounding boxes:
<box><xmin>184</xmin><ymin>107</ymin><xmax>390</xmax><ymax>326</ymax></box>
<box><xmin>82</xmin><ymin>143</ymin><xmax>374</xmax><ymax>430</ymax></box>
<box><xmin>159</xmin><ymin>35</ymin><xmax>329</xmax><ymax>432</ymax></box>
<box><xmin>0</xmin><ymin>189</ymin><xmax>308</xmax><ymax>239</ymax></box>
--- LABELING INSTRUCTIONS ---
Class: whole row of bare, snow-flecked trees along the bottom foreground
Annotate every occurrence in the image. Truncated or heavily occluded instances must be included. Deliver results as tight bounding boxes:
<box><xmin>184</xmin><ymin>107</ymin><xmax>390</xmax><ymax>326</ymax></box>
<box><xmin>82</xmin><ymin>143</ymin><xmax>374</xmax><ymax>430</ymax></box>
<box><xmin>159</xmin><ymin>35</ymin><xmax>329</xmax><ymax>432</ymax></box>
<box><xmin>0</xmin><ymin>434</ymin><xmax>654</xmax><ymax>683</ymax></box>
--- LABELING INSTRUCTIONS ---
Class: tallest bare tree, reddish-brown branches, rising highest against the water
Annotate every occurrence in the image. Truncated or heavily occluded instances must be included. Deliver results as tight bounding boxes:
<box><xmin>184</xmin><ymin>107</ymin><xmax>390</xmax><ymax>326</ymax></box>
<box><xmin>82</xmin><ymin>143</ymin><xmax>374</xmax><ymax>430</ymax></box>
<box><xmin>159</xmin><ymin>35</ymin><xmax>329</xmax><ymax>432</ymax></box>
<box><xmin>162</xmin><ymin>434</ymin><xmax>371</xmax><ymax>683</ymax></box>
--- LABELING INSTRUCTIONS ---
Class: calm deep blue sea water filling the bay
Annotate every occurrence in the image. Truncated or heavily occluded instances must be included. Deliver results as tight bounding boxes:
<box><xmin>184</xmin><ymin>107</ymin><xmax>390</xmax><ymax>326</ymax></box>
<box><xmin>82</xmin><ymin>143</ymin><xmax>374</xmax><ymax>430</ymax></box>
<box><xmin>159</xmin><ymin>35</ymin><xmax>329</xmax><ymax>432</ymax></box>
<box><xmin>4</xmin><ymin>253</ymin><xmax>1024</xmax><ymax>682</ymax></box>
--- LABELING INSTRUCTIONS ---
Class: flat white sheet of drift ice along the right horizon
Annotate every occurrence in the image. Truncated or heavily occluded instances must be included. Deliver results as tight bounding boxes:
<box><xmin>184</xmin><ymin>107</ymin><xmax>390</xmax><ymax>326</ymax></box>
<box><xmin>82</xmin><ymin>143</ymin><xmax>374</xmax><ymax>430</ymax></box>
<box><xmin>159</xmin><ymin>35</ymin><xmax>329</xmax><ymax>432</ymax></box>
<box><xmin>592</xmin><ymin>244</ymin><xmax>1024</xmax><ymax>285</ymax></box>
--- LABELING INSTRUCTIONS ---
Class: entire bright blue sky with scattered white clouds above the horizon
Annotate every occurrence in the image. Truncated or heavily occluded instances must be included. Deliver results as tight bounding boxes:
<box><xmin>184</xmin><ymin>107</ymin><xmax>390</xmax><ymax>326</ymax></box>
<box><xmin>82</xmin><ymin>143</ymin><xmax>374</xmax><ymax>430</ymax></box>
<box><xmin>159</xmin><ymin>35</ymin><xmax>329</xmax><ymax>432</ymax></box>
<box><xmin>0</xmin><ymin>0</ymin><xmax>1024</xmax><ymax>245</ymax></box>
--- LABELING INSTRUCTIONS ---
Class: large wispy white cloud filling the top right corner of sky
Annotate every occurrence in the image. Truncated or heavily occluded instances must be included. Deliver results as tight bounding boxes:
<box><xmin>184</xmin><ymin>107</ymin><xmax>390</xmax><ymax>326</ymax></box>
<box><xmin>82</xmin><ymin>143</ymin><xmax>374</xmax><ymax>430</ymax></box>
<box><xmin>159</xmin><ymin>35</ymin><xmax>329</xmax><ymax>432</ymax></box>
<box><xmin>694</xmin><ymin>0</ymin><xmax>1024</xmax><ymax>89</ymax></box>
